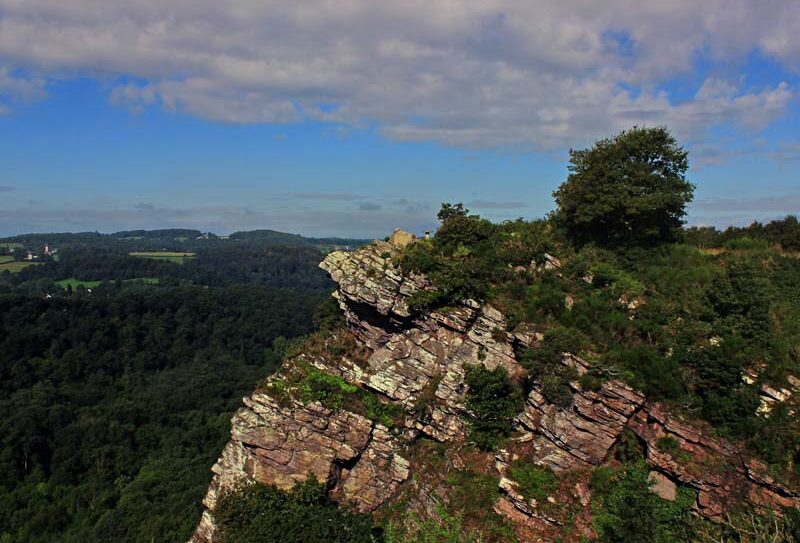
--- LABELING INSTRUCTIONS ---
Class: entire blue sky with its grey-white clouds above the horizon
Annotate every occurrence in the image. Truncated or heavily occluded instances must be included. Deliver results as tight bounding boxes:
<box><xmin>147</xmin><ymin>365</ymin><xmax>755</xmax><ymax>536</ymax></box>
<box><xmin>0</xmin><ymin>0</ymin><xmax>800</xmax><ymax>237</ymax></box>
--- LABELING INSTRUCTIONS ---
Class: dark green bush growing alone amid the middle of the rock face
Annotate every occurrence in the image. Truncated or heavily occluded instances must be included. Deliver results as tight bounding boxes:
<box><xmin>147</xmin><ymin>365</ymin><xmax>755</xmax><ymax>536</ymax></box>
<box><xmin>466</xmin><ymin>366</ymin><xmax>522</xmax><ymax>450</ymax></box>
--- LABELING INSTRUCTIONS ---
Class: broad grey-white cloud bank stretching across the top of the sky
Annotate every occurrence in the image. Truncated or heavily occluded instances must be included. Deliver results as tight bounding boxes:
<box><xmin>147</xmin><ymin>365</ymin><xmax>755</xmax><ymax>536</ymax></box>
<box><xmin>0</xmin><ymin>0</ymin><xmax>800</xmax><ymax>149</ymax></box>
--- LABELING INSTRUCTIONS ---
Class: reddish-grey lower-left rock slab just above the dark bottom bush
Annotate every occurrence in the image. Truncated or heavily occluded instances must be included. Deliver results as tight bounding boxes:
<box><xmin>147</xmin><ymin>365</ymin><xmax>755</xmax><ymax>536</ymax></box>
<box><xmin>192</xmin><ymin>393</ymin><xmax>408</xmax><ymax>542</ymax></box>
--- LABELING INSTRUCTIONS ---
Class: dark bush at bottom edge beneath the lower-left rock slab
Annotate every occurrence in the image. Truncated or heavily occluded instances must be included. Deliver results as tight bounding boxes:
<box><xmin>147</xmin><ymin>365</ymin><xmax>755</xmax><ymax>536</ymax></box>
<box><xmin>214</xmin><ymin>477</ymin><xmax>380</xmax><ymax>543</ymax></box>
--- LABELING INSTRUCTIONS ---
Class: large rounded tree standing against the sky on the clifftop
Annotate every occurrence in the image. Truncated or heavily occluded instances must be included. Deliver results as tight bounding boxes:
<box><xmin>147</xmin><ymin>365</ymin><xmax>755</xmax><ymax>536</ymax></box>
<box><xmin>553</xmin><ymin>128</ymin><xmax>694</xmax><ymax>247</ymax></box>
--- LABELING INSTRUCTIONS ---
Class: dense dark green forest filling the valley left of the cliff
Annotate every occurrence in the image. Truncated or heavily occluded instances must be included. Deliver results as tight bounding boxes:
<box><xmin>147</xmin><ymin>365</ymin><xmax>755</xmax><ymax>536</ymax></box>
<box><xmin>0</xmin><ymin>231</ymin><xmax>358</xmax><ymax>543</ymax></box>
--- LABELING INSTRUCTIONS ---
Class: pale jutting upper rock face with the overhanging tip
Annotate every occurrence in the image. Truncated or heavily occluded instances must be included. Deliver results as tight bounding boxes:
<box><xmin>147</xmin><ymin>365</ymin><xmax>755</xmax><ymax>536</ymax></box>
<box><xmin>320</xmin><ymin>240</ymin><xmax>522</xmax><ymax>441</ymax></box>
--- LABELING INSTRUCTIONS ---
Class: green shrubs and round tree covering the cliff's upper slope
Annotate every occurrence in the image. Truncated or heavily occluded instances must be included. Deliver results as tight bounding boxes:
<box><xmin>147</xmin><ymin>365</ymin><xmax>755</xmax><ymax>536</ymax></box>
<box><xmin>400</xmin><ymin>128</ymin><xmax>800</xmax><ymax>484</ymax></box>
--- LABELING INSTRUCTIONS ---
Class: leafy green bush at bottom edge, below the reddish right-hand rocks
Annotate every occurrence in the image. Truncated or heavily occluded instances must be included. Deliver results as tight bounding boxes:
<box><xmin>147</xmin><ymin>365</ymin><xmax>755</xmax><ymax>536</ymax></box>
<box><xmin>591</xmin><ymin>462</ymin><xmax>696</xmax><ymax>543</ymax></box>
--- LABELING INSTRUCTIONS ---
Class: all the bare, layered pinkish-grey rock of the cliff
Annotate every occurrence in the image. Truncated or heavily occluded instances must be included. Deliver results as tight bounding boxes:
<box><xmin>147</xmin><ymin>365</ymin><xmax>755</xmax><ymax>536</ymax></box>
<box><xmin>192</xmin><ymin>233</ymin><xmax>800</xmax><ymax>543</ymax></box>
